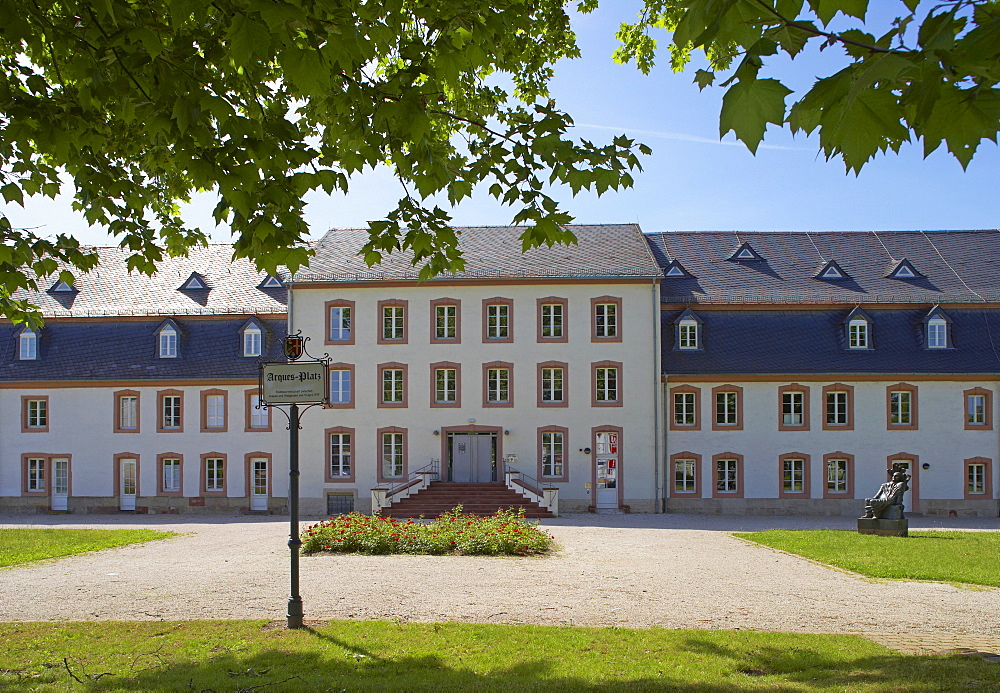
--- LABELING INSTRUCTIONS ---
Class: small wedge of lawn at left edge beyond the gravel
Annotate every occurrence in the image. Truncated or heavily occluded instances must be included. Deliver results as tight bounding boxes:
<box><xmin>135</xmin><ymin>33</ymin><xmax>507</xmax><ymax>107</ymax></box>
<box><xmin>0</xmin><ymin>528</ymin><xmax>175</xmax><ymax>568</ymax></box>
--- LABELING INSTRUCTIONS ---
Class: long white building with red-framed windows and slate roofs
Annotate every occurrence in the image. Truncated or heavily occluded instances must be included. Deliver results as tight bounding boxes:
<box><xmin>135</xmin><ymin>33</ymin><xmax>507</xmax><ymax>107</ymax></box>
<box><xmin>0</xmin><ymin>225</ymin><xmax>1000</xmax><ymax>517</ymax></box>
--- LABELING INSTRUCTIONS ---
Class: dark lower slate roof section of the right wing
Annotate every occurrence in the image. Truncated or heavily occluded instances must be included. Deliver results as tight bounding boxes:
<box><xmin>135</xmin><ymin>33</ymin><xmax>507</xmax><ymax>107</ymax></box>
<box><xmin>661</xmin><ymin>307</ymin><xmax>1000</xmax><ymax>378</ymax></box>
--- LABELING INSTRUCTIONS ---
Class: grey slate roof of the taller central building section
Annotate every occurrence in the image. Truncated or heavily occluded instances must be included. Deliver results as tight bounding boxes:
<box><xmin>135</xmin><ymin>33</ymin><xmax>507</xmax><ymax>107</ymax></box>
<box><xmin>295</xmin><ymin>224</ymin><xmax>661</xmax><ymax>283</ymax></box>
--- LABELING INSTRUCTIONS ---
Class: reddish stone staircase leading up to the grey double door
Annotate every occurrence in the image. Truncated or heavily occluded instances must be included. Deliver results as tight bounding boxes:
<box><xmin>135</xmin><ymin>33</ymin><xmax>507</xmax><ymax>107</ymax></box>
<box><xmin>382</xmin><ymin>481</ymin><xmax>553</xmax><ymax>519</ymax></box>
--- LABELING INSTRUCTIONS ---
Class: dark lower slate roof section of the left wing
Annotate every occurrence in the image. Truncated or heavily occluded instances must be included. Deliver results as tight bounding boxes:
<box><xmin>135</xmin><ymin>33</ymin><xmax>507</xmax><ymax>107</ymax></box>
<box><xmin>0</xmin><ymin>317</ymin><xmax>286</xmax><ymax>382</ymax></box>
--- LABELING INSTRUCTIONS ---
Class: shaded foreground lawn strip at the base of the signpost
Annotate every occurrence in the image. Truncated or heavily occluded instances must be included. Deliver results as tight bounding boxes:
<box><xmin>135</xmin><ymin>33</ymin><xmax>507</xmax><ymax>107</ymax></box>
<box><xmin>0</xmin><ymin>621</ymin><xmax>1000</xmax><ymax>693</ymax></box>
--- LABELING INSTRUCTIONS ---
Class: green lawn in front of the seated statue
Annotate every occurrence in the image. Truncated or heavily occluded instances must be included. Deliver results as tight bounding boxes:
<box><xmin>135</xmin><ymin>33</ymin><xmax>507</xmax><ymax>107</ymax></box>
<box><xmin>734</xmin><ymin>529</ymin><xmax>1000</xmax><ymax>587</ymax></box>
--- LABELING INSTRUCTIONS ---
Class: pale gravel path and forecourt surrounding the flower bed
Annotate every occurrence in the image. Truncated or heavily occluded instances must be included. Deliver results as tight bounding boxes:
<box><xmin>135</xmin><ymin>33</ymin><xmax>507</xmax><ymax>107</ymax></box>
<box><xmin>0</xmin><ymin>508</ymin><xmax>1000</xmax><ymax>653</ymax></box>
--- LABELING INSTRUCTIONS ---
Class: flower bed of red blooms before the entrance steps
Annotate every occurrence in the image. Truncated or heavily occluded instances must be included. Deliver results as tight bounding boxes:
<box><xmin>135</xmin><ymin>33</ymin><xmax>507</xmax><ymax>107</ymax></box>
<box><xmin>302</xmin><ymin>506</ymin><xmax>552</xmax><ymax>556</ymax></box>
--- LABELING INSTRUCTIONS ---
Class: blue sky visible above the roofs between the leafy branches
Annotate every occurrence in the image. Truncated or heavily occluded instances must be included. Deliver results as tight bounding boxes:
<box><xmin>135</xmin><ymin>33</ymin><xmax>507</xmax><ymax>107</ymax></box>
<box><xmin>5</xmin><ymin>0</ymin><xmax>1000</xmax><ymax>245</ymax></box>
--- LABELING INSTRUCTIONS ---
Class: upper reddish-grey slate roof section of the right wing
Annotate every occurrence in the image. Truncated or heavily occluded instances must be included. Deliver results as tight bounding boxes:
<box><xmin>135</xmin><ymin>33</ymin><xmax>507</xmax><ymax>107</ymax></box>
<box><xmin>646</xmin><ymin>230</ymin><xmax>1000</xmax><ymax>306</ymax></box>
